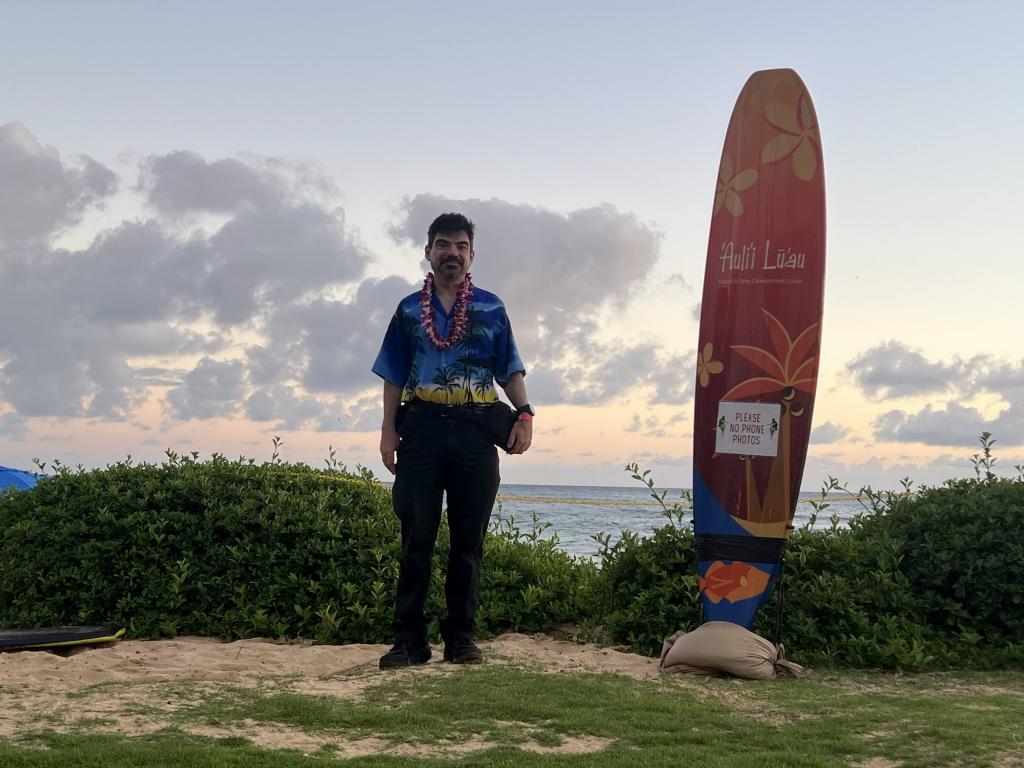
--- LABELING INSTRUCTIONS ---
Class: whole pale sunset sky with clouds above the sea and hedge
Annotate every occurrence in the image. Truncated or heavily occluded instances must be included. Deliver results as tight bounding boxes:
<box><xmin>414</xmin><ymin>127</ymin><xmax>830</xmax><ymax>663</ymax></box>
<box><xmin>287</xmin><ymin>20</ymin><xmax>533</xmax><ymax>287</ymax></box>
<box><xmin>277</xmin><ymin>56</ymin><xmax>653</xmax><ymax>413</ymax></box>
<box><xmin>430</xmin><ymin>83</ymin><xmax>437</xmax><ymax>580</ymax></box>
<box><xmin>0</xmin><ymin>0</ymin><xmax>1024</xmax><ymax>488</ymax></box>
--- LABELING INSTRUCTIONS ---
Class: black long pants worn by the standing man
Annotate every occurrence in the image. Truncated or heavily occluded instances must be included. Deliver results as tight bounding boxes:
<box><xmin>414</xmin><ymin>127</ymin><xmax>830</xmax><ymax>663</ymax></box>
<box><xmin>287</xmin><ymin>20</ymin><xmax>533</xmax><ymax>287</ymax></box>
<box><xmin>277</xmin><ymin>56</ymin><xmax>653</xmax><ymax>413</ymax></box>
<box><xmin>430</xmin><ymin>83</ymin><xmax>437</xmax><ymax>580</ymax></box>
<box><xmin>391</xmin><ymin>409</ymin><xmax>500</xmax><ymax>642</ymax></box>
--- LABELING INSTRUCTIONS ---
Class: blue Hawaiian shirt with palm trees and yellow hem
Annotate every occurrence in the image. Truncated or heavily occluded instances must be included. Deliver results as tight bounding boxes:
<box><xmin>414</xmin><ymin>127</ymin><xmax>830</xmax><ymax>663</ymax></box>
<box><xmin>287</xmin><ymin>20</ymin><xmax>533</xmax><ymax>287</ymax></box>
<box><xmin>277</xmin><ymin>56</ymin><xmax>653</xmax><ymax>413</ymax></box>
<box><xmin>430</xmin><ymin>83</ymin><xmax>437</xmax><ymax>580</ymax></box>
<box><xmin>373</xmin><ymin>286</ymin><xmax>526</xmax><ymax>406</ymax></box>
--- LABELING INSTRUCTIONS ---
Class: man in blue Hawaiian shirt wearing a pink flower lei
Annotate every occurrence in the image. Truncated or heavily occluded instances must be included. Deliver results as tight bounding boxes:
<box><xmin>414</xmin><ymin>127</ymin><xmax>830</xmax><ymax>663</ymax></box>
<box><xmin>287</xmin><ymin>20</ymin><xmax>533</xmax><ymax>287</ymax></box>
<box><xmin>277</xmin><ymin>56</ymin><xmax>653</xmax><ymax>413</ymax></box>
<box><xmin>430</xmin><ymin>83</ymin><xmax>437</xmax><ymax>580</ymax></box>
<box><xmin>373</xmin><ymin>213</ymin><xmax>534</xmax><ymax>669</ymax></box>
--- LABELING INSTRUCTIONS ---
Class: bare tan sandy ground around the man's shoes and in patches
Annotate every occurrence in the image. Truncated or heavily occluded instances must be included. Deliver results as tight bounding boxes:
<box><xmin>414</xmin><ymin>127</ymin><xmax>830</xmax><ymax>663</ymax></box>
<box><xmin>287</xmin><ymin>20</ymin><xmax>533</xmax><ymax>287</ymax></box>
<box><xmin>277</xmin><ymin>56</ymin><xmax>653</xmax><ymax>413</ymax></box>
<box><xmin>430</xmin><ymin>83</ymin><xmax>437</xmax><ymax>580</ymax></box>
<box><xmin>0</xmin><ymin>634</ymin><xmax>659</xmax><ymax>757</ymax></box>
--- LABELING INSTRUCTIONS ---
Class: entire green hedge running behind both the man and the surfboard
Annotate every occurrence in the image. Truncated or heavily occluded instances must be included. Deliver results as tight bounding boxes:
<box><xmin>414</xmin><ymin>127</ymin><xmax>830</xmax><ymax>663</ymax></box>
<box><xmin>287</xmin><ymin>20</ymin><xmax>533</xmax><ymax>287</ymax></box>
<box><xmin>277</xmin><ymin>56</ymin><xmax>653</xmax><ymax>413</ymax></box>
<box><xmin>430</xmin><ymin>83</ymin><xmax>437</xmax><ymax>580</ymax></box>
<box><xmin>0</xmin><ymin>454</ymin><xmax>1024</xmax><ymax>670</ymax></box>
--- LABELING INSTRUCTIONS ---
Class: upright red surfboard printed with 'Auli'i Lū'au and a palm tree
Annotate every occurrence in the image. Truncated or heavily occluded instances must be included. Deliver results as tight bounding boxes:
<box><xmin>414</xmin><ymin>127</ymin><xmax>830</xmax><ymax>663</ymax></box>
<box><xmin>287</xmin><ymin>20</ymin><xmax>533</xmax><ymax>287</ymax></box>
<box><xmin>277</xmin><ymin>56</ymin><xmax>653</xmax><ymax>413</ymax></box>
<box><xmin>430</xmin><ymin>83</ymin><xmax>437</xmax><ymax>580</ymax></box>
<box><xmin>693</xmin><ymin>70</ymin><xmax>825</xmax><ymax>629</ymax></box>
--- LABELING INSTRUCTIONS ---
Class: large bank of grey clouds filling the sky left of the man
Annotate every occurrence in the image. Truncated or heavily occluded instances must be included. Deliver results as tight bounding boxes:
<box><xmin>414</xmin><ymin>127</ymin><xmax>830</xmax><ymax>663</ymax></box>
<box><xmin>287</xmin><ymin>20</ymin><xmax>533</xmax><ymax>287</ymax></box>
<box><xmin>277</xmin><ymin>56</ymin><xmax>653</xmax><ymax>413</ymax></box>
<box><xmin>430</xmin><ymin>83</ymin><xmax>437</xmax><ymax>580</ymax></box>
<box><xmin>0</xmin><ymin>124</ymin><xmax>376</xmax><ymax>423</ymax></box>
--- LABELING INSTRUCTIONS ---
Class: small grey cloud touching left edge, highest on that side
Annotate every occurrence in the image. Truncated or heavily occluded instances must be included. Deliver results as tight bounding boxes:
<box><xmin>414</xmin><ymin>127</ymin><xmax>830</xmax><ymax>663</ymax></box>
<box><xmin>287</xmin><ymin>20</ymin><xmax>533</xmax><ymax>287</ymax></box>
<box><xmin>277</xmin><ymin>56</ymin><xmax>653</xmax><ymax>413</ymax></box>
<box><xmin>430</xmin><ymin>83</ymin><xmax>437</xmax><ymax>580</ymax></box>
<box><xmin>0</xmin><ymin>123</ymin><xmax>117</xmax><ymax>247</ymax></box>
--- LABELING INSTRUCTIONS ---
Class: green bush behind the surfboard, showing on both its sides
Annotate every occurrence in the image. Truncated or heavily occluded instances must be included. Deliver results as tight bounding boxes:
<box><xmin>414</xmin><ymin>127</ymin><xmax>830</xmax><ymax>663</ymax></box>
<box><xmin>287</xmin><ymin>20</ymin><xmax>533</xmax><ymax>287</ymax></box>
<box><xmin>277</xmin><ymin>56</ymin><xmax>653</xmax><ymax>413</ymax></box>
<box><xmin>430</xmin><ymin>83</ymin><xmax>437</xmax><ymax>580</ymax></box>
<box><xmin>587</xmin><ymin>477</ymin><xmax>1024</xmax><ymax>670</ymax></box>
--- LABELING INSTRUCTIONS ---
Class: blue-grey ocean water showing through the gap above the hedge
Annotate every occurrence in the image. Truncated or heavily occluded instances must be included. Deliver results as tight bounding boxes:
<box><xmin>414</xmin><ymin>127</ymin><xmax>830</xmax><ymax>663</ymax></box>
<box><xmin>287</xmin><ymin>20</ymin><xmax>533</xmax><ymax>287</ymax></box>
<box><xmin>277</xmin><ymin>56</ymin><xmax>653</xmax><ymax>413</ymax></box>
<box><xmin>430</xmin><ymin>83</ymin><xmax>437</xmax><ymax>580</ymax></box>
<box><xmin>492</xmin><ymin>483</ymin><xmax>864</xmax><ymax>557</ymax></box>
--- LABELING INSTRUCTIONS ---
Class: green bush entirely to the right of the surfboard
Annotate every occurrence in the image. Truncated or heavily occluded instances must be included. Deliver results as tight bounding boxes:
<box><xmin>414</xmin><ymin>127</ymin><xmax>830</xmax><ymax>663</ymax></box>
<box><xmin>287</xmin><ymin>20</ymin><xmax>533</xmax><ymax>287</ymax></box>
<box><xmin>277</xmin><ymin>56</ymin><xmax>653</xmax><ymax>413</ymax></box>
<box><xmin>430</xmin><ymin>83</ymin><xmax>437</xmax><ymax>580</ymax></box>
<box><xmin>760</xmin><ymin>477</ymin><xmax>1024</xmax><ymax>670</ymax></box>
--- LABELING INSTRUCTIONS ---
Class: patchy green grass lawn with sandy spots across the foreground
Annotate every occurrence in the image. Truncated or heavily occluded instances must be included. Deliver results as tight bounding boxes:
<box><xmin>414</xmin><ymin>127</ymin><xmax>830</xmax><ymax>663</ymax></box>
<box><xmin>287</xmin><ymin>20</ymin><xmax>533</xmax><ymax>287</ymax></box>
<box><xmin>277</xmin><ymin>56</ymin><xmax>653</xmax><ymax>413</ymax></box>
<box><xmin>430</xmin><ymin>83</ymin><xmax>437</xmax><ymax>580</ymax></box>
<box><xmin>0</xmin><ymin>664</ymin><xmax>1024</xmax><ymax>768</ymax></box>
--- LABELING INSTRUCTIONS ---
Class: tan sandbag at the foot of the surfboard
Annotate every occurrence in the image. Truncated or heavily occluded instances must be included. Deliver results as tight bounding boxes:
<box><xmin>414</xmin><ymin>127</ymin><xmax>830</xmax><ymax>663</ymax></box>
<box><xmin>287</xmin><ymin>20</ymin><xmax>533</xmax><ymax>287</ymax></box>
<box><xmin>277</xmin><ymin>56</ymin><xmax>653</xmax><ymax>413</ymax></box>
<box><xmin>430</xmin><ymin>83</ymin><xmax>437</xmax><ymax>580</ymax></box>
<box><xmin>658</xmin><ymin>622</ymin><xmax>804</xmax><ymax>680</ymax></box>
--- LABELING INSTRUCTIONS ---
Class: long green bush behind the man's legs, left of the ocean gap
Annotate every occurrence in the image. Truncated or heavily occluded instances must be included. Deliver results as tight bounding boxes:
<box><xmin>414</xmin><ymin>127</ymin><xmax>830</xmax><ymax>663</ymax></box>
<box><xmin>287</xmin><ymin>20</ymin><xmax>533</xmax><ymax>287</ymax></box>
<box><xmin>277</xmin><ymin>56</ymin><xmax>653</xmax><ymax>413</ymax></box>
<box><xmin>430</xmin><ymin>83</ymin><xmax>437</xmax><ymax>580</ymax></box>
<box><xmin>0</xmin><ymin>454</ymin><xmax>578</xmax><ymax>643</ymax></box>
